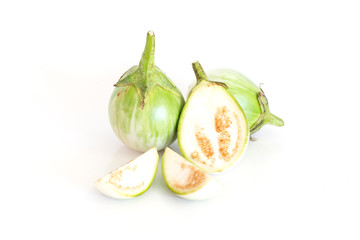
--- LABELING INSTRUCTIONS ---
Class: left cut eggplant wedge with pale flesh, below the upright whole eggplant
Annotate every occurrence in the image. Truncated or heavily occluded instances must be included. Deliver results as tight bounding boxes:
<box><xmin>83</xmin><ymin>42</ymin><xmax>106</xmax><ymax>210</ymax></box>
<box><xmin>95</xmin><ymin>147</ymin><xmax>159</xmax><ymax>198</ymax></box>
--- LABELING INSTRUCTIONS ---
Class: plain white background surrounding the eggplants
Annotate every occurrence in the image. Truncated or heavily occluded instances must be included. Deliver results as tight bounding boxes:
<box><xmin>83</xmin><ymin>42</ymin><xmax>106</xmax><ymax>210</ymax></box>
<box><xmin>0</xmin><ymin>0</ymin><xmax>360</xmax><ymax>239</ymax></box>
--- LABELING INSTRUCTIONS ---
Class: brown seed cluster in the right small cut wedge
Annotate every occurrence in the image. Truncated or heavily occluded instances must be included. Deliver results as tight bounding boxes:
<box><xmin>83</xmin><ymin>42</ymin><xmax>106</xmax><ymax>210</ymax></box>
<box><xmin>174</xmin><ymin>163</ymin><xmax>206</xmax><ymax>190</ymax></box>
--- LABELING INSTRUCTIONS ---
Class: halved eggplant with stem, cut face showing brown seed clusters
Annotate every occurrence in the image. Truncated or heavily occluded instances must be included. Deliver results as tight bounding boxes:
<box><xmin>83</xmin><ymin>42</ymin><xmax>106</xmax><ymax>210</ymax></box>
<box><xmin>178</xmin><ymin>62</ymin><xmax>249</xmax><ymax>173</ymax></box>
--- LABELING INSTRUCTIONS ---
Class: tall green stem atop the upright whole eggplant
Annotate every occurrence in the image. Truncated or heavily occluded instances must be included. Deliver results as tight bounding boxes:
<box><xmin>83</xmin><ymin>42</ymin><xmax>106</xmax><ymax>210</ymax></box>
<box><xmin>139</xmin><ymin>31</ymin><xmax>155</xmax><ymax>81</ymax></box>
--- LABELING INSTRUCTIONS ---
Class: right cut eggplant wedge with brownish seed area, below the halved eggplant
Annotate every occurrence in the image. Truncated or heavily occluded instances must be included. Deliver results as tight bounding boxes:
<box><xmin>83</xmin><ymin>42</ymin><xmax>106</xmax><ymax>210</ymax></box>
<box><xmin>162</xmin><ymin>148</ymin><xmax>223</xmax><ymax>200</ymax></box>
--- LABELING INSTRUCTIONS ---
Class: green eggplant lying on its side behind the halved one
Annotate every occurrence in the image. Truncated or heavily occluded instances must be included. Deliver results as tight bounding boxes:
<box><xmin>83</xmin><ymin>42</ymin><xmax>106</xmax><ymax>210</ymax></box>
<box><xmin>207</xmin><ymin>69</ymin><xmax>284</xmax><ymax>134</ymax></box>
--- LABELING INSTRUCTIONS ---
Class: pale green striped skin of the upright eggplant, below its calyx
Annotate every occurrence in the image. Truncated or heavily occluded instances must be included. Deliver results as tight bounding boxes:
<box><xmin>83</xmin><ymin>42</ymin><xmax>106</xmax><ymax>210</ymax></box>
<box><xmin>109</xmin><ymin>86</ymin><xmax>184</xmax><ymax>152</ymax></box>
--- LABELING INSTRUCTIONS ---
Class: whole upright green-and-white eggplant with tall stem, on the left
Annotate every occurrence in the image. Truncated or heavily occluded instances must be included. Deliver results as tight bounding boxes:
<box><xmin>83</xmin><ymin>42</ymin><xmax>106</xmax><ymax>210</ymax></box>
<box><xmin>109</xmin><ymin>31</ymin><xmax>185</xmax><ymax>152</ymax></box>
